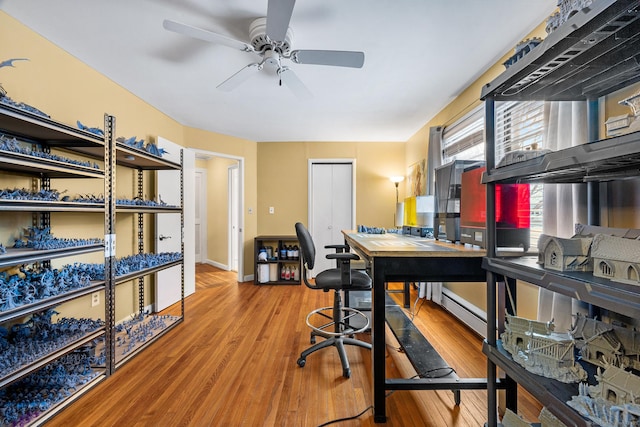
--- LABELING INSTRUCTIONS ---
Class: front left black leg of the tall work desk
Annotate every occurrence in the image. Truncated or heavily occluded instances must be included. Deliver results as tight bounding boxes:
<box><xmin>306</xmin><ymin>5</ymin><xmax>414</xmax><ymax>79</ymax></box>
<box><xmin>371</xmin><ymin>259</ymin><xmax>387</xmax><ymax>423</ymax></box>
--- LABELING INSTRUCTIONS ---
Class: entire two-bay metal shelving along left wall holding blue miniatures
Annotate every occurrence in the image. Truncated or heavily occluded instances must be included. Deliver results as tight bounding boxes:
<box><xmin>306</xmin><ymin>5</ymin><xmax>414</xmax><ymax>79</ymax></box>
<box><xmin>0</xmin><ymin>103</ymin><xmax>184</xmax><ymax>425</ymax></box>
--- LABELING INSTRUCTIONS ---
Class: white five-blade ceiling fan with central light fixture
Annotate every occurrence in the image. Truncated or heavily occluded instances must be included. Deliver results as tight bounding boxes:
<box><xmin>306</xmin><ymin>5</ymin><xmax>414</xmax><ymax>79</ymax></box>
<box><xmin>162</xmin><ymin>0</ymin><xmax>364</xmax><ymax>98</ymax></box>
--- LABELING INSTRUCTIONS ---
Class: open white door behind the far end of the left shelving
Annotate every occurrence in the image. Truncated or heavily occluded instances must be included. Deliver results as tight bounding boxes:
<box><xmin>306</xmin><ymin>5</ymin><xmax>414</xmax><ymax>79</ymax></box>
<box><xmin>153</xmin><ymin>137</ymin><xmax>196</xmax><ymax>311</ymax></box>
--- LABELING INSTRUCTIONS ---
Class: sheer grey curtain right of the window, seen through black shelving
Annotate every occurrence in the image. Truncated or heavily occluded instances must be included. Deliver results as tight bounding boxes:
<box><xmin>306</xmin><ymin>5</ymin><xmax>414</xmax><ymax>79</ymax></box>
<box><xmin>538</xmin><ymin>101</ymin><xmax>587</xmax><ymax>332</ymax></box>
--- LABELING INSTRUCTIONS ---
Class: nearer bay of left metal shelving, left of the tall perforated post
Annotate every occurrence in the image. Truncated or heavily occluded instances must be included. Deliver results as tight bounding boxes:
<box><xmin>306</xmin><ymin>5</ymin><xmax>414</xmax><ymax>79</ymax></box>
<box><xmin>0</xmin><ymin>104</ymin><xmax>111</xmax><ymax>424</ymax></box>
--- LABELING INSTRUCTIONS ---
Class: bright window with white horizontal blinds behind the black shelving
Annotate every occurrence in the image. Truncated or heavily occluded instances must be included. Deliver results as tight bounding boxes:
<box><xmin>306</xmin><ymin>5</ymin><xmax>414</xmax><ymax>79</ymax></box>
<box><xmin>442</xmin><ymin>101</ymin><xmax>545</xmax><ymax>251</ymax></box>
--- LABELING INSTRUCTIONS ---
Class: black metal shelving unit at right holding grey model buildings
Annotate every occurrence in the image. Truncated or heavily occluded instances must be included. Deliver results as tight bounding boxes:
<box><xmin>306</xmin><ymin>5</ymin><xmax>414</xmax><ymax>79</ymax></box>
<box><xmin>481</xmin><ymin>0</ymin><xmax>640</xmax><ymax>427</ymax></box>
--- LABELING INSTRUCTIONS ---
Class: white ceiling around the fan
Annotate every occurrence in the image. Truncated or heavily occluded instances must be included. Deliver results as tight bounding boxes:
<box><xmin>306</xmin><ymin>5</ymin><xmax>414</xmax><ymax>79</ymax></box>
<box><xmin>0</xmin><ymin>0</ymin><xmax>556</xmax><ymax>141</ymax></box>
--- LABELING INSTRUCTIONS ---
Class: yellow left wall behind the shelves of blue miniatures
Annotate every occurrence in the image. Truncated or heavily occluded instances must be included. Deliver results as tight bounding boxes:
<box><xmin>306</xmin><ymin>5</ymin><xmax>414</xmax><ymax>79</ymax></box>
<box><xmin>0</xmin><ymin>11</ymin><xmax>257</xmax><ymax>319</ymax></box>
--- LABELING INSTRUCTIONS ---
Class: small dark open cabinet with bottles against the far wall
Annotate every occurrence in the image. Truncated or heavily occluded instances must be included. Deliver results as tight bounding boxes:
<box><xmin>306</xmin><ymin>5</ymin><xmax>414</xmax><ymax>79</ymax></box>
<box><xmin>253</xmin><ymin>236</ymin><xmax>302</xmax><ymax>285</ymax></box>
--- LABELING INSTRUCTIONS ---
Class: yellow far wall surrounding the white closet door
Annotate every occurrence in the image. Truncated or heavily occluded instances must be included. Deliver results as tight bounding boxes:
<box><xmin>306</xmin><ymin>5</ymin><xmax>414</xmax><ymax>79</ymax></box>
<box><xmin>257</xmin><ymin>142</ymin><xmax>406</xmax><ymax>236</ymax></box>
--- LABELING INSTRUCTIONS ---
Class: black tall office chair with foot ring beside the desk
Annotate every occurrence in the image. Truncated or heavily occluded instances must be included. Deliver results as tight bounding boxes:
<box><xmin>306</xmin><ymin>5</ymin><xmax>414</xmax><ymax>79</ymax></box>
<box><xmin>296</xmin><ymin>222</ymin><xmax>371</xmax><ymax>378</ymax></box>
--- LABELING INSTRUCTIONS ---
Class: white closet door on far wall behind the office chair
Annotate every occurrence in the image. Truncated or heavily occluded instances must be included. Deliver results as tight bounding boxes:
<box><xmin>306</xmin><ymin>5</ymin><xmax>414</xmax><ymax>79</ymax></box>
<box><xmin>309</xmin><ymin>160</ymin><xmax>355</xmax><ymax>276</ymax></box>
